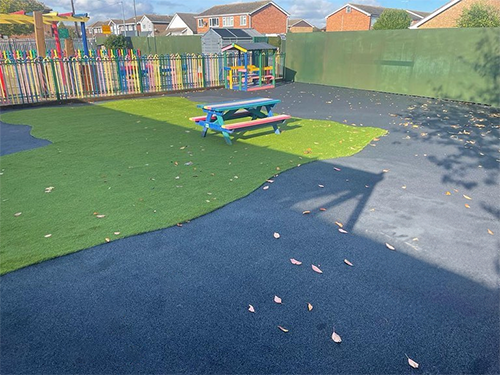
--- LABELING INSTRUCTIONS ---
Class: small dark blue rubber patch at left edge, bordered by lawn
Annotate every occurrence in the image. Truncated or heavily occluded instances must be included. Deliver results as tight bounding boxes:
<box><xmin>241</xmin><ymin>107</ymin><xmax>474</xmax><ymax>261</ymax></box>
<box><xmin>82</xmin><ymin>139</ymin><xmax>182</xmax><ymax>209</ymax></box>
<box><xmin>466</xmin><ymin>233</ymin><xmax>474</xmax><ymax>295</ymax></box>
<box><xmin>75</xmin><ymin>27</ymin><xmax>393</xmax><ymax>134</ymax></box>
<box><xmin>0</xmin><ymin>121</ymin><xmax>52</xmax><ymax>156</ymax></box>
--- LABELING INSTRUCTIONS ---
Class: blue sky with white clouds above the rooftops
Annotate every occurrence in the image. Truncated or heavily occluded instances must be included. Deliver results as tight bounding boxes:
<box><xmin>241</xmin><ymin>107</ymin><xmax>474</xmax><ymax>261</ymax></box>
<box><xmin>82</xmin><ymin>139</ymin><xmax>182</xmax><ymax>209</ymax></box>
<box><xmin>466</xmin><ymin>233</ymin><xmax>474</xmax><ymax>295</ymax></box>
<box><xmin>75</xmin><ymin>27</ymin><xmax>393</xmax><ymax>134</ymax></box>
<box><xmin>41</xmin><ymin>0</ymin><xmax>448</xmax><ymax>28</ymax></box>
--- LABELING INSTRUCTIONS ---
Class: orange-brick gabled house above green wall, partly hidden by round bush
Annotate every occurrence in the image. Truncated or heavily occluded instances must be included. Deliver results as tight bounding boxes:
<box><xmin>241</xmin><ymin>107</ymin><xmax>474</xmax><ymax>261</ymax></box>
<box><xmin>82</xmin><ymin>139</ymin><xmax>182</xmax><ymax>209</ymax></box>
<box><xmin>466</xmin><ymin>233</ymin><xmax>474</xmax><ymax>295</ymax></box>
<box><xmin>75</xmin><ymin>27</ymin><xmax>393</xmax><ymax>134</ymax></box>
<box><xmin>326</xmin><ymin>3</ymin><xmax>429</xmax><ymax>31</ymax></box>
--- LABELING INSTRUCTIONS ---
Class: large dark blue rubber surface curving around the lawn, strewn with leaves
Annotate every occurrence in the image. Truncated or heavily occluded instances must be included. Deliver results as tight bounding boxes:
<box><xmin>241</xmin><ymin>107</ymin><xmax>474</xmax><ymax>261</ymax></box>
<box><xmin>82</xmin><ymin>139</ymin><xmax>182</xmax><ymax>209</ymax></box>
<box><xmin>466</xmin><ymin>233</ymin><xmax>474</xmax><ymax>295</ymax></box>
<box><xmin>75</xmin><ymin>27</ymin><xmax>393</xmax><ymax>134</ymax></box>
<box><xmin>0</xmin><ymin>84</ymin><xmax>500</xmax><ymax>374</ymax></box>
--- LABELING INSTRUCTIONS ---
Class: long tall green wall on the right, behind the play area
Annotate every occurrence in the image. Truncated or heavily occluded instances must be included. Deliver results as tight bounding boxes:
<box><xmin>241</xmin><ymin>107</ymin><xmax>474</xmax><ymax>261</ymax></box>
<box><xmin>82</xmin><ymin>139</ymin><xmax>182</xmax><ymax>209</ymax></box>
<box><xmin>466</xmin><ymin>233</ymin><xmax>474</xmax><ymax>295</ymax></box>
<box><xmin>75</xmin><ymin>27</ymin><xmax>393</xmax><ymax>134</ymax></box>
<box><xmin>286</xmin><ymin>28</ymin><xmax>500</xmax><ymax>107</ymax></box>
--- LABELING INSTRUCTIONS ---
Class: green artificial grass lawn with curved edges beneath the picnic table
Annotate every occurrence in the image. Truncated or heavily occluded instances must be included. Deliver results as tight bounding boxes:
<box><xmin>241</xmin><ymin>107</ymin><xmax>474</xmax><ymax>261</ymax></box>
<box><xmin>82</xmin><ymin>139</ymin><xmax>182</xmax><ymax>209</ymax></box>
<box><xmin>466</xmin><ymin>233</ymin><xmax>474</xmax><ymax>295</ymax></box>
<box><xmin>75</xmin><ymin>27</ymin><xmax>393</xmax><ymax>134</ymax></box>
<box><xmin>0</xmin><ymin>97</ymin><xmax>385</xmax><ymax>274</ymax></box>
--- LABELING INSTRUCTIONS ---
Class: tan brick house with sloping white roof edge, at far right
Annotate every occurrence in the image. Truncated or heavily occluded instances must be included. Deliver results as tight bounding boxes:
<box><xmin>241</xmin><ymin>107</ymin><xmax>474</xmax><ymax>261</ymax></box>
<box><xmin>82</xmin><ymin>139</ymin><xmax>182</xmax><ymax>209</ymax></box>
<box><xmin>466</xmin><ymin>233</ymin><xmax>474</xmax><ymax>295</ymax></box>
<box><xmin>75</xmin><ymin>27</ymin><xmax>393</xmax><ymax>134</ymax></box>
<box><xmin>410</xmin><ymin>0</ymin><xmax>500</xmax><ymax>29</ymax></box>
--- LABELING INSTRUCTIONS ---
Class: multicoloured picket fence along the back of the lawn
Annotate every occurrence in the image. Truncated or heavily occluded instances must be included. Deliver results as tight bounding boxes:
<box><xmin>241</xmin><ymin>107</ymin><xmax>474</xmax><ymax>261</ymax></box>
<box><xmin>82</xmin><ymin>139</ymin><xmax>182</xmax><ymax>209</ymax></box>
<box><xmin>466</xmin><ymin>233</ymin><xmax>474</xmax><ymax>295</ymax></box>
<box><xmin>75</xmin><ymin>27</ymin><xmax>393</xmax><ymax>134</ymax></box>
<box><xmin>0</xmin><ymin>54</ymin><xmax>284</xmax><ymax>105</ymax></box>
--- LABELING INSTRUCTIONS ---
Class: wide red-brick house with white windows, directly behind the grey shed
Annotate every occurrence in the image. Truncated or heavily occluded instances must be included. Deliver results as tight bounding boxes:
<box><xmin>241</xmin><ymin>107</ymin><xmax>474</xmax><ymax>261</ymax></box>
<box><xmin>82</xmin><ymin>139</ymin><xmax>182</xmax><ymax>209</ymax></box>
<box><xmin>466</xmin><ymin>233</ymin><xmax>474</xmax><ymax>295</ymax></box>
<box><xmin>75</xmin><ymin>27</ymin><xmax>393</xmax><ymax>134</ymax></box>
<box><xmin>195</xmin><ymin>1</ymin><xmax>290</xmax><ymax>34</ymax></box>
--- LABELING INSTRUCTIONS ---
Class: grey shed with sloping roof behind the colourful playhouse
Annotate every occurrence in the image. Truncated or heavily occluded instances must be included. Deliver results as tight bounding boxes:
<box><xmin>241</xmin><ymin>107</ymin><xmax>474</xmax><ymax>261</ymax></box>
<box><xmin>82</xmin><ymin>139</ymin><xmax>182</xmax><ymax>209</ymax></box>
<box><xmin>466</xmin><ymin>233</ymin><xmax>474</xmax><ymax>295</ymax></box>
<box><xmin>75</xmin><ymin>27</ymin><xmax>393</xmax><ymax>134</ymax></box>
<box><xmin>201</xmin><ymin>28</ymin><xmax>263</xmax><ymax>53</ymax></box>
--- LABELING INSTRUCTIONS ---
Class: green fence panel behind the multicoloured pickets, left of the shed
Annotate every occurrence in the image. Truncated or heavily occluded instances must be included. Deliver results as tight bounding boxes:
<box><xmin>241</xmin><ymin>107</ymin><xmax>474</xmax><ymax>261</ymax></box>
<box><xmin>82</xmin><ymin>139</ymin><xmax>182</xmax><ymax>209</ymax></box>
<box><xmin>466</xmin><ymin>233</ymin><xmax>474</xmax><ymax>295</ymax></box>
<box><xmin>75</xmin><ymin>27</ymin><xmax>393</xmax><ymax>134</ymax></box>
<box><xmin>97</xmin><ymin>35</ymin><xmax>201</xmax><ymax>55</ymax></box>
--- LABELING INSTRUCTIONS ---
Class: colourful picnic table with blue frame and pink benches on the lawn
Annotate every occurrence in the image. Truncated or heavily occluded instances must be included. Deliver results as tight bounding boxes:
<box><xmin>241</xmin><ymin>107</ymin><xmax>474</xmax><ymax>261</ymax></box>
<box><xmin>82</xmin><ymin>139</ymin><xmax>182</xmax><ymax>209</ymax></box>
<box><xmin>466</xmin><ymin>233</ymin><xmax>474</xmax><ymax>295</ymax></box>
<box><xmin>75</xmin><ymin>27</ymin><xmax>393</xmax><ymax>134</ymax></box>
<box><xmin>190</xmin><ymin>98</ymin><xmax>290</xmax><ymax>145</ymax></box>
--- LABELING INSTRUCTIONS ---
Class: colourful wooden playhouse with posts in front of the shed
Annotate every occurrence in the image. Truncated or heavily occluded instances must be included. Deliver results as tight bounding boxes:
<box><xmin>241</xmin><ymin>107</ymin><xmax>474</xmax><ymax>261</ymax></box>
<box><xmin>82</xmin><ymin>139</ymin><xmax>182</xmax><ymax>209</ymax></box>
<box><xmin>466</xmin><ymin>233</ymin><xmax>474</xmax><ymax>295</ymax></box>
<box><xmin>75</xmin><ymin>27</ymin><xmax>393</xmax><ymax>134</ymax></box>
<box><xmin>222</xmin><ymin>42</ymin><xmax>277</xmax><ymax>91</ymax></box>
